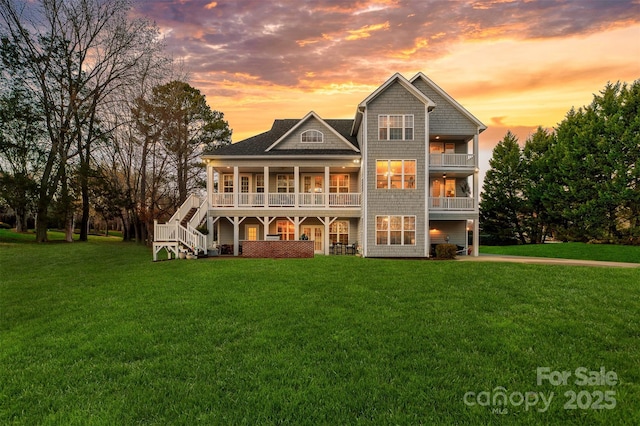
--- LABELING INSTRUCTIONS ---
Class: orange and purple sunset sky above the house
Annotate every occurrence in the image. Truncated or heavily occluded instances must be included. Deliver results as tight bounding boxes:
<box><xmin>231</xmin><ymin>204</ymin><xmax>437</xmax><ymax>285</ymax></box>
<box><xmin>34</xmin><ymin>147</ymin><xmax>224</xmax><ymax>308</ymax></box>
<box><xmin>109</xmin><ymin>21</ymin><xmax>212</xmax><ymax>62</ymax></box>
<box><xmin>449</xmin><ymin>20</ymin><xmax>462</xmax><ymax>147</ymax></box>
<box><xmin>138</xmin><ymin>0</ymin><xmax>640</xmax><ymax>179</ymax></box>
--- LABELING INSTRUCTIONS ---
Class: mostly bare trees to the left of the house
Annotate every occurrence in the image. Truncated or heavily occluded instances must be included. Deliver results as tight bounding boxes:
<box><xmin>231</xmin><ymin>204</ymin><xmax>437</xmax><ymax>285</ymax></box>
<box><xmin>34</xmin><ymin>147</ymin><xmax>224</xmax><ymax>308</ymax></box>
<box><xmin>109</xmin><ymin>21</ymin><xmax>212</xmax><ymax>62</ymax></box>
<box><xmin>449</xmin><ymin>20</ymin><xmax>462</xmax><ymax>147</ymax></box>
<box><xmin>0</xmin><ymin>0</ymin><xmax>231</xmax><ymax>242</ymax></box>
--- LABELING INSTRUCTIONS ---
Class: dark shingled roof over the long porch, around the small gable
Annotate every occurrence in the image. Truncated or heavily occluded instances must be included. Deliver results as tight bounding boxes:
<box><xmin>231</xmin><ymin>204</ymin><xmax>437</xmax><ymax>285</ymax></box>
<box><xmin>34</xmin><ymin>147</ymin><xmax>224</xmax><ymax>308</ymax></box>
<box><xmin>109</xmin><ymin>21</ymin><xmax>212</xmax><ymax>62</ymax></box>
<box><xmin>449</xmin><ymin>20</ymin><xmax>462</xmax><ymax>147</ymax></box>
<box><xmin>202</xmin><ymin>119</ymin><xmax>359</xmax><ymax>157</ymax></box>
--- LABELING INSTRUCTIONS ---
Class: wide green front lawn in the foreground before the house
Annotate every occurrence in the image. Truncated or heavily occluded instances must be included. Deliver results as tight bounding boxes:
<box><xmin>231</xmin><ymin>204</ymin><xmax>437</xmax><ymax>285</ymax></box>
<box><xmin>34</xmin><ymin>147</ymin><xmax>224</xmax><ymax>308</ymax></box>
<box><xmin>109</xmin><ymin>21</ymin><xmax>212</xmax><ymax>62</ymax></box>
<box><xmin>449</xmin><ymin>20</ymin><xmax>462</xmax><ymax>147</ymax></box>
<box><xmin>0</xmin><ymin>231</ymin><xmax>640</xmax><ymax>425</ymax></box>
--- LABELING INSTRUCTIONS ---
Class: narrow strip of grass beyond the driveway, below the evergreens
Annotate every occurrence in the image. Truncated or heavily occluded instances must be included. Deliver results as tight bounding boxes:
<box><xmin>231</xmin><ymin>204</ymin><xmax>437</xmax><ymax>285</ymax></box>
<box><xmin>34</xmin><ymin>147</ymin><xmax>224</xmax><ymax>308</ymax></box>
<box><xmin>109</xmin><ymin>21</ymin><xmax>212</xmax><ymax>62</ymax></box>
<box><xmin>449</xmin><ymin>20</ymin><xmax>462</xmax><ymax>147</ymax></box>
<box><xmin>480</xmin><ymin>243</ymin><xmax>640</xmax><ymax>263</ymax></box>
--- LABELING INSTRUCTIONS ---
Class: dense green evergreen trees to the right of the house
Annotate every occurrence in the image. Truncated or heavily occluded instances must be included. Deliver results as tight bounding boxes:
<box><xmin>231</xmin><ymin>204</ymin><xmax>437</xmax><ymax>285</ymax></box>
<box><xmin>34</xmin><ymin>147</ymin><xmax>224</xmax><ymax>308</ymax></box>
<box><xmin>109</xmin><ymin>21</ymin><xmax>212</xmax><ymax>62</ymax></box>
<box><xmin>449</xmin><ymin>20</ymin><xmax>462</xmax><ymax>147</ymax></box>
<box><xmin>480</xmin><ymin>80</ymin><xmax>640</xmax><ymax>244</ymax></box>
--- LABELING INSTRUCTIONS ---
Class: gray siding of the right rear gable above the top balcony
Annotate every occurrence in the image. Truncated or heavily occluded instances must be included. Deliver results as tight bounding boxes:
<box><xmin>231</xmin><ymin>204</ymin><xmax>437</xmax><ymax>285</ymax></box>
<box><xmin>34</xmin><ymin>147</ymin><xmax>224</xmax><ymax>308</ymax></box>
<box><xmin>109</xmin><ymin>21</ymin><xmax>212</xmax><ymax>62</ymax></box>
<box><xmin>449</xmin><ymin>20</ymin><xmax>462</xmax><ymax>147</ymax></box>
<box><xmin>413</xmin><ymin>78</ymin><xmax>477</xmax><ymax>135</ymax></box>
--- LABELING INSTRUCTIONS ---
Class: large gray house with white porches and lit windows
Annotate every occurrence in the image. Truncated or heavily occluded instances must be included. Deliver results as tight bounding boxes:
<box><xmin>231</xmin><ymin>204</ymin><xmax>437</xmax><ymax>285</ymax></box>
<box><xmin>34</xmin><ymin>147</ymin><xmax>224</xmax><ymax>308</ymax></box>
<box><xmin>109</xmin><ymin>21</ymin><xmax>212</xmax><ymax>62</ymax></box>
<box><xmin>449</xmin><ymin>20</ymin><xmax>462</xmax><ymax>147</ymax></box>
<box><xmin>154</xmin><ymin>73</ymin><xmax>486</xmax><ymax>257</ymax></box>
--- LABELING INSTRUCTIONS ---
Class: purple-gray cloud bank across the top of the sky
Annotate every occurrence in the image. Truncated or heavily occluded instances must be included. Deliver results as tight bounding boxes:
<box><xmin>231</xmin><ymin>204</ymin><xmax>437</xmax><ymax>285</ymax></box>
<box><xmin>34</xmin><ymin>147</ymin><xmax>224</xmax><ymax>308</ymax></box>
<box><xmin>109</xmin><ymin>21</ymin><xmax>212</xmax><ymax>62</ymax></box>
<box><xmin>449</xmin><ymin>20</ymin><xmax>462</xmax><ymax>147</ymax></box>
<box><xmin>138</xmin><ymin>0</ymin><xmax>640</xmax><ymax>88</ymax></box>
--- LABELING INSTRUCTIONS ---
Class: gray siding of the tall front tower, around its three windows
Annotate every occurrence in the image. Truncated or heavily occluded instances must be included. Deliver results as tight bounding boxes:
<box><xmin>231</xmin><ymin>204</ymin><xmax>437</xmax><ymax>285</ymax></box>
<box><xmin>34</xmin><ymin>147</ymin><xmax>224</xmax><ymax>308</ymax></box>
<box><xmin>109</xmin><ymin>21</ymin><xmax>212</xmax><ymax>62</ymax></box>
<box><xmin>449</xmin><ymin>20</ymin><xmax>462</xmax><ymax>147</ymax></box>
<box><xmin>363</xmin><ymin>83</ymin><xmax>426</xmax><ymax>257</ymax></box>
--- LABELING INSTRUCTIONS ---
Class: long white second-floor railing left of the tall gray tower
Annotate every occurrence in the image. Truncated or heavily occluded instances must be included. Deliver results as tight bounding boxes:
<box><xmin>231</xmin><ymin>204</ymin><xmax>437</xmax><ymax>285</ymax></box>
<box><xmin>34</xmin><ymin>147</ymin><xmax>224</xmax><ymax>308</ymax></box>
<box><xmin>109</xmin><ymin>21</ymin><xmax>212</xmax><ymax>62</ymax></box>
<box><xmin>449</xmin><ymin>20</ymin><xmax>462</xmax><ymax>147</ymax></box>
<box><xmin>211</xmin><ymin>192</ymin><xmax>361</xmax><ymax>208</ymax></box>
